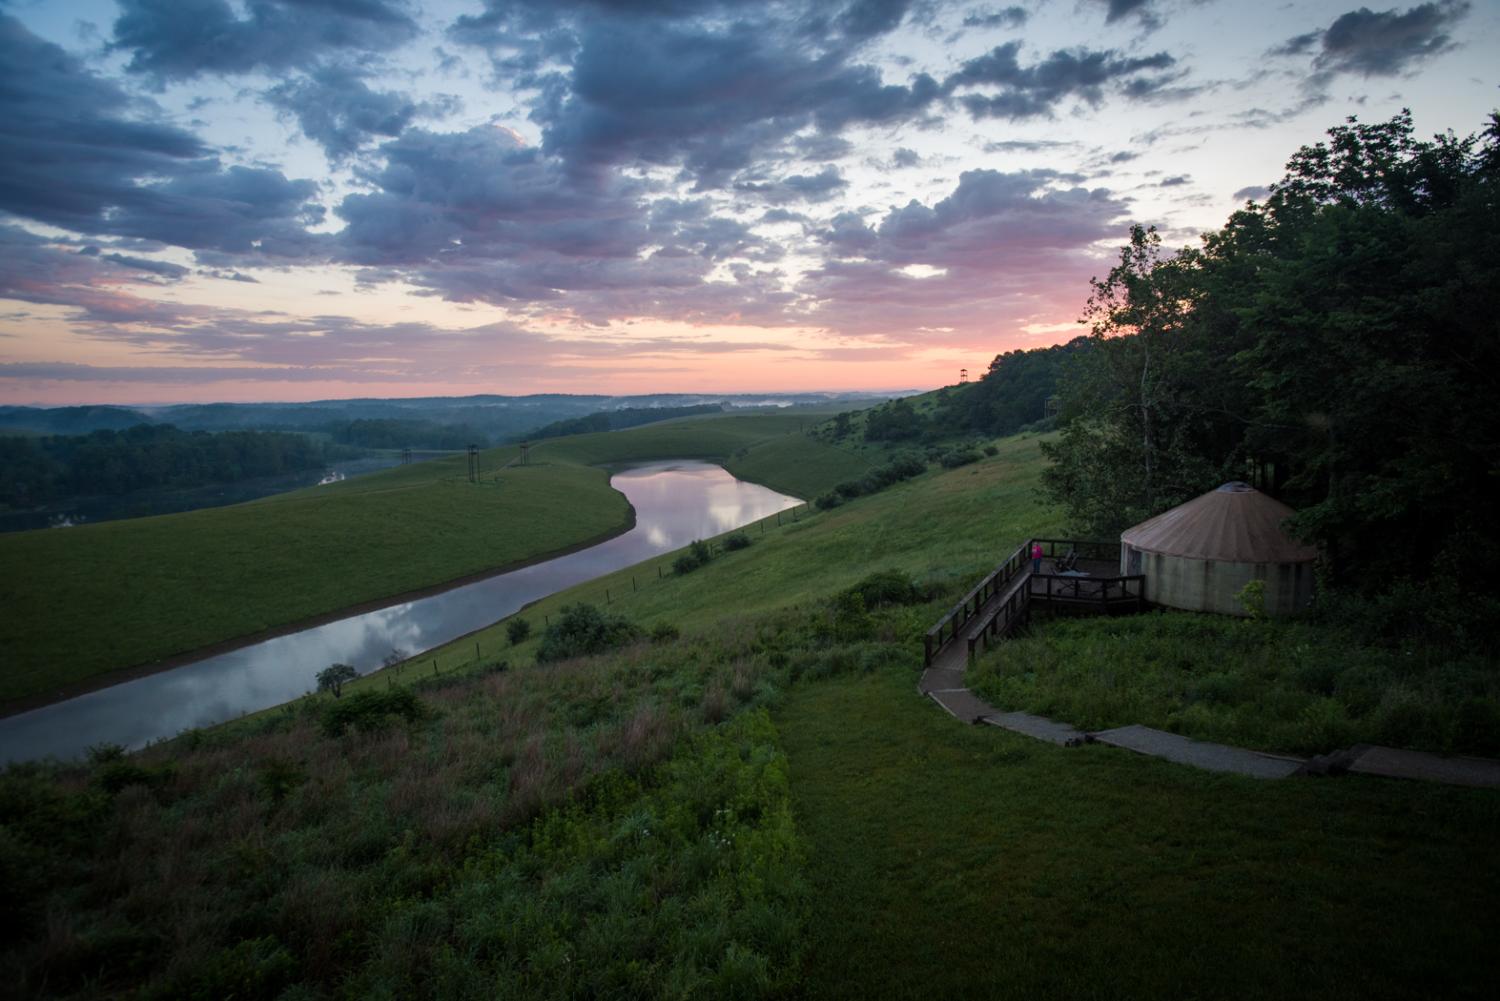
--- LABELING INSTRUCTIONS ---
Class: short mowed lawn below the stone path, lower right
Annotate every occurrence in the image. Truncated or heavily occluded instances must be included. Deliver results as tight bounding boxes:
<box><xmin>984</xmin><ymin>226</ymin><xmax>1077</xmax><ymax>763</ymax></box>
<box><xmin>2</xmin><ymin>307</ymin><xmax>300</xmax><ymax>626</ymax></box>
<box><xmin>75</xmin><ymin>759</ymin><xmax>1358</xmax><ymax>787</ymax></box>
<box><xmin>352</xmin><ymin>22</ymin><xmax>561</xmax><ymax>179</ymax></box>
<box><xmin>777</xmin><ymin>663</ymin><xmax>1500</xmax><ymax>999</ymax></box>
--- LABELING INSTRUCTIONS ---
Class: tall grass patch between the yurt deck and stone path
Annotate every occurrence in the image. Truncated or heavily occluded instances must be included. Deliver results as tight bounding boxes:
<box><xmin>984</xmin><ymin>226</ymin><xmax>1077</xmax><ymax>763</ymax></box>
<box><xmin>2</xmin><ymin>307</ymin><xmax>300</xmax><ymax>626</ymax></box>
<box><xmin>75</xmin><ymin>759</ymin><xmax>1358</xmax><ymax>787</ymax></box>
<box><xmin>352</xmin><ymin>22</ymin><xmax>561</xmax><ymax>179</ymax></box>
<box><xmin>971</xmin><ymin>612</ymin><xmax>1500</xmax><ymax>755</ymax></box>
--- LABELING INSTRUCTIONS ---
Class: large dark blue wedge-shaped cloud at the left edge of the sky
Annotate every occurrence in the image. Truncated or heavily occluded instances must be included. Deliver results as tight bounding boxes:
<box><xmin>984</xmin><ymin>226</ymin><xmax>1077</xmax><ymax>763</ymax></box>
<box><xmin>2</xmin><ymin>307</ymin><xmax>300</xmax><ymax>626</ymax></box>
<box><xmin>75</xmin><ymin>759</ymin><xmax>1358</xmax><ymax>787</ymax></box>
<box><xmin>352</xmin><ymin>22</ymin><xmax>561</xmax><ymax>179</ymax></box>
<box><xmin>0</xmin><ymin>17</ymin><xmax>321</xmax><ymax>257</ymax></box>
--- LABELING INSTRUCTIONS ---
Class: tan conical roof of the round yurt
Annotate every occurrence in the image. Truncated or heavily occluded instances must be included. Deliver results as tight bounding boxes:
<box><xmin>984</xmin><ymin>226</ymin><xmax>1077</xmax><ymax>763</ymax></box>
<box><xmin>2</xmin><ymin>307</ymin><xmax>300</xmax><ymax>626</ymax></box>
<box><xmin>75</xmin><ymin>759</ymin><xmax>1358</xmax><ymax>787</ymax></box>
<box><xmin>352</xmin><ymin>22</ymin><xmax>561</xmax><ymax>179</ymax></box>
<box><xmin>1121</xmin><ymin>482</ymin><xmax>1317</xmax><ymax>563</ymax></box>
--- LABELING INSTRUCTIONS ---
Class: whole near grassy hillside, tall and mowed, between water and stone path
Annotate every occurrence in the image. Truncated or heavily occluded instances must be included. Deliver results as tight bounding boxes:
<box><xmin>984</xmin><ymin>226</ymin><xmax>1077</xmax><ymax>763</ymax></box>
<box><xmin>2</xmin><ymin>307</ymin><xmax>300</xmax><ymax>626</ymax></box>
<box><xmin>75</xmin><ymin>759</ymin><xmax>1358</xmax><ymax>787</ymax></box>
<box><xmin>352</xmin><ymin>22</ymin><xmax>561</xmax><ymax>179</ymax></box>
<box><xmin>0</xmin><ymin>438</ymin><xmax>1500</xmax><ymax>998</ymax></box>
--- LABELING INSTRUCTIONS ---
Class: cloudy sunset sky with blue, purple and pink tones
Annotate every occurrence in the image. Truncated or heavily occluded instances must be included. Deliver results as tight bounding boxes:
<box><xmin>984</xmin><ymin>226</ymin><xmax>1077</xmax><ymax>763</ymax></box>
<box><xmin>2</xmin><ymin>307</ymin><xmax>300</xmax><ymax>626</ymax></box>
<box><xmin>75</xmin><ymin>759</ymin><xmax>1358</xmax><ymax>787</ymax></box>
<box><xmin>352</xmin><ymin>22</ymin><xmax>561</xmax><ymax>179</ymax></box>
<box><xmin>0</xmin><ymin>0</ymin><xmax>1500</xmax><ymax>404</ymax></box>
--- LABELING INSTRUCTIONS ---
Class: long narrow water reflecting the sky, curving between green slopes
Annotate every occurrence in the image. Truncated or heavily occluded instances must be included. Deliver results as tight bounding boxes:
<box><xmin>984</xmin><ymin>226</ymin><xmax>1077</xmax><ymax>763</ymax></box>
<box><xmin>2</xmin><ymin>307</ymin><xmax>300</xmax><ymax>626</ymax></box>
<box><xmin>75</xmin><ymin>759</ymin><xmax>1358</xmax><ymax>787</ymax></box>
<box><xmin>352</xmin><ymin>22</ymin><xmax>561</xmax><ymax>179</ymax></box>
<box><xmin>0</xmin><ymin>462</ymin><xmax>798</xmax><ymax>761</ymax></box>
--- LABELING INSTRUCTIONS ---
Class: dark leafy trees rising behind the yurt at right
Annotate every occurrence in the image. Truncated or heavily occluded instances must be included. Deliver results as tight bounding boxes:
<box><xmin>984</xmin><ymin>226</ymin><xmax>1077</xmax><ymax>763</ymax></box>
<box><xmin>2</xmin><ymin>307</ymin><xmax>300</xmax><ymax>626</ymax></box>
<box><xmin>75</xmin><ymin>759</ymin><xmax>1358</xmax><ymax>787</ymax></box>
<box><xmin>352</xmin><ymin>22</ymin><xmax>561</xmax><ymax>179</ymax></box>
<box><xmin>1038</xmin><ymin>113</ymin><xmax>1500</xmax><ymax>590</ymax></box>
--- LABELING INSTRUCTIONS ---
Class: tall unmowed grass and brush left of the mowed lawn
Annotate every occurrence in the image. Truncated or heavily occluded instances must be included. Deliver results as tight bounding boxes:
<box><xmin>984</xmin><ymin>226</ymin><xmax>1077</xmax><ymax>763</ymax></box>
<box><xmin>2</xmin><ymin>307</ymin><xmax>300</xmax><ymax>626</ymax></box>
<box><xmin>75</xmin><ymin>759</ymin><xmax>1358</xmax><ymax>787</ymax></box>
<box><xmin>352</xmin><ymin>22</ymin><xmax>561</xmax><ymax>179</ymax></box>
<box><xmin>0</xmin><ymin>591</ymin><xmax>893</xmax><ymax>998</ymax></box>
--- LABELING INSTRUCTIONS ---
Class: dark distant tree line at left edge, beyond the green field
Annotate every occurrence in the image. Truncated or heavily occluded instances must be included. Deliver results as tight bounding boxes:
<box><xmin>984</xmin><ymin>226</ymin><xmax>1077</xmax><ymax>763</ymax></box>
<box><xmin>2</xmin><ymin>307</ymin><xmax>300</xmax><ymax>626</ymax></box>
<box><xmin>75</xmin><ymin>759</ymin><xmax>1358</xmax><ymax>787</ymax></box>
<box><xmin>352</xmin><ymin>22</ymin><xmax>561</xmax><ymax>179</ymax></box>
<box><xmin>0</xmin><ymin>425</ymin><xmax>350</xmax><ymax>510</ymax></box>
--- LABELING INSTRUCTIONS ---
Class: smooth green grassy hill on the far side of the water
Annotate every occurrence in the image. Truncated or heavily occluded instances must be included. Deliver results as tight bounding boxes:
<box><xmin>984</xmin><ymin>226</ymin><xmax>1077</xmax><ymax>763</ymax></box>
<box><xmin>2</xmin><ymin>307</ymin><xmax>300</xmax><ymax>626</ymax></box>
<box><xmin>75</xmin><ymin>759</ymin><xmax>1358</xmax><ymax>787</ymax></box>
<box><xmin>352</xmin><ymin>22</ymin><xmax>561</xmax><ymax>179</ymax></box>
<box><xmin>0</xmin><ymin>414</ymin><xmax>864</xmax><ymax>702</ymax></box>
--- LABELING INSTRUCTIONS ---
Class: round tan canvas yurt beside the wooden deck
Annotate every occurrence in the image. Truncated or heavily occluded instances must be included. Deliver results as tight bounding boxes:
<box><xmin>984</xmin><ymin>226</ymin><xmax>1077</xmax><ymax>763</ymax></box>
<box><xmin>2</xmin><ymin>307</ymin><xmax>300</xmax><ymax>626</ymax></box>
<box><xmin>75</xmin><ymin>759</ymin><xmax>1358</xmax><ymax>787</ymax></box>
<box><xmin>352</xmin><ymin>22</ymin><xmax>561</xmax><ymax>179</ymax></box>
<box><xmin>1121</xmin><ymin>483</ymin><xmax>1317</xmax><ymax>615</ymax></box>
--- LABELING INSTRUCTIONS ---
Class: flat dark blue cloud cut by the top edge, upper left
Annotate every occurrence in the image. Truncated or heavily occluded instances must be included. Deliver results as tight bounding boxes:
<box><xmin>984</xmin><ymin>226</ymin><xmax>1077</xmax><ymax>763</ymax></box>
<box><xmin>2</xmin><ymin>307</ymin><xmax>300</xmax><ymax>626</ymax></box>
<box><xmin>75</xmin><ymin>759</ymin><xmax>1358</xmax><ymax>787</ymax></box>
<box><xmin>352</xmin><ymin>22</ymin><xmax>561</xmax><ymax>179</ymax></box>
<box><xmin>114</xmin><ymin>0</ymin><xmax>417</xmax><ymax>80</ymax></box>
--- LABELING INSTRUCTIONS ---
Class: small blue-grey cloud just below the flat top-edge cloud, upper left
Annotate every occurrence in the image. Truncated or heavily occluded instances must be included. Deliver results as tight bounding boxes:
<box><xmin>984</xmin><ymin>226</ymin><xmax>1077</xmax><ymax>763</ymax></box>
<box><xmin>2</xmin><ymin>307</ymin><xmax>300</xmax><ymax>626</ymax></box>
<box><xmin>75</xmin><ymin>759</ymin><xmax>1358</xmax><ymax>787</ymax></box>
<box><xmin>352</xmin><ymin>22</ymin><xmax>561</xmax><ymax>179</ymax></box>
<box><xmin>266</xmin><ymin>66</ymin><xmax>452</xmax><ymax>161</ymax></box>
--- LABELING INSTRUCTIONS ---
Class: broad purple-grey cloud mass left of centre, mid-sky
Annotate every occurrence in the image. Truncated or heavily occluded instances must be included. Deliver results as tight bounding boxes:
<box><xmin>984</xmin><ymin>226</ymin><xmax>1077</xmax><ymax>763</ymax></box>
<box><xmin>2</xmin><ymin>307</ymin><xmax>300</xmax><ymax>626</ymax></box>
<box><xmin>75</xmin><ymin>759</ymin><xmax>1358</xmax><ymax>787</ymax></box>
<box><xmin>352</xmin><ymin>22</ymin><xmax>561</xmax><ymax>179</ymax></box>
<box><xmin>328</xmin><ymin>126</ymin><xmax>798</xmax><ymax>313</ymax></box>
